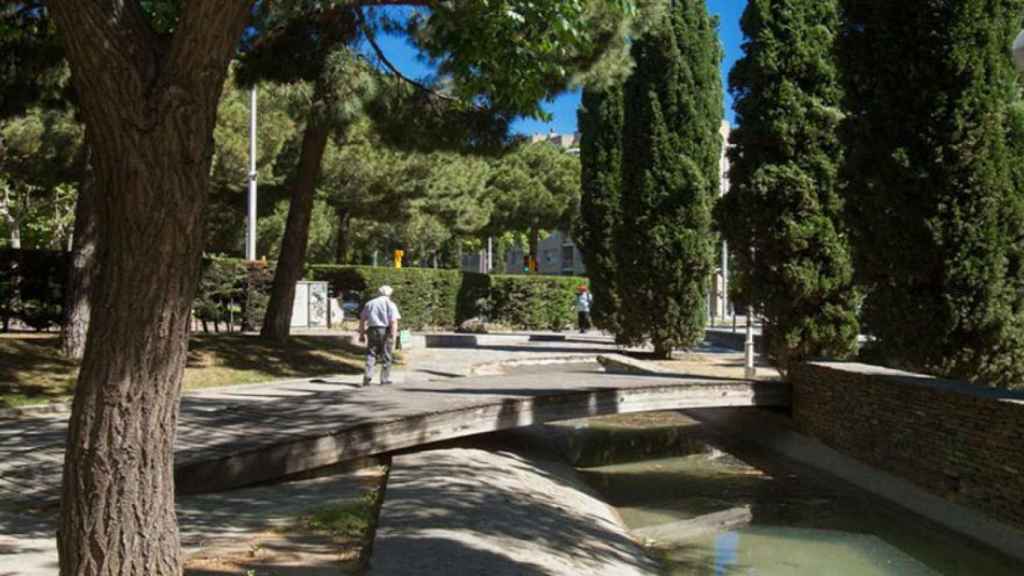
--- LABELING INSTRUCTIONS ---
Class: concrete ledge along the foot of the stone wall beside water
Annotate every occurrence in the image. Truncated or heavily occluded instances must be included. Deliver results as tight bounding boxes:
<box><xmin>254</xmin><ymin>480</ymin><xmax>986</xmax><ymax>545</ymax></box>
<box><xmin>688</xmin><ymin>410</ymin><xmax>1024</xmax><ymax>561</ymax></box>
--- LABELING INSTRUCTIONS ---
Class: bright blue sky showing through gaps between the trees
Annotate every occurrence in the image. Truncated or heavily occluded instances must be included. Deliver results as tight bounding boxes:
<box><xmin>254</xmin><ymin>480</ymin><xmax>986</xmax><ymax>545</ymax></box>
<box><xmin>368</xmin><ymin>0</ymin><xmax>746</xmax><ymax>134</ymax></box>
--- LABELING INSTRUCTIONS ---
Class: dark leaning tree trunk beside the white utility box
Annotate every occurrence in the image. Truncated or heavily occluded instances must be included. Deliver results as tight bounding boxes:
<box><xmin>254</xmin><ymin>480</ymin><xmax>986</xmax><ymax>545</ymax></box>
<box><xmin>260</xmin><ymin>117</ymin><xmax>330</xmax><ymax>341</ymax></box>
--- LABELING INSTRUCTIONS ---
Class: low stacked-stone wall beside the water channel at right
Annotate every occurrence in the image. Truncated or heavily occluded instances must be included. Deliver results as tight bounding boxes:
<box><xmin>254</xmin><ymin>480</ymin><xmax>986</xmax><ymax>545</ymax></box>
<box><xmin>791</xmin><ymin>363</ymin><xmax>1024</xmax><ymax>529</ymax></box>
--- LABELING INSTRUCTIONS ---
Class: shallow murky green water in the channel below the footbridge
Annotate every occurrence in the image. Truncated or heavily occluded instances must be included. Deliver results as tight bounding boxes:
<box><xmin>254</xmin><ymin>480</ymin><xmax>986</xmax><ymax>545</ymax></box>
<box><xmin>580</xmin><ymin>436</ymin><xmax>1024</xmax><ymax>576</ymax></box>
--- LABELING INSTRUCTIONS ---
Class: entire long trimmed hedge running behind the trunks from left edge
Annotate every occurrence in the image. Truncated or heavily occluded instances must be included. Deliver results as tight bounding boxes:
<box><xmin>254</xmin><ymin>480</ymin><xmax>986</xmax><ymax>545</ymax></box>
<box><xmin>0</xmin><ymin>249</ymin><xmax>587</xmax><ymax>330</ymax></box>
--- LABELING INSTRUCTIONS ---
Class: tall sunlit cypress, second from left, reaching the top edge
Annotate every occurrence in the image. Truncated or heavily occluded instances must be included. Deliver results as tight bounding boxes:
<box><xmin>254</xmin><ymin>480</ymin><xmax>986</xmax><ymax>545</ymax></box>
<box><xmin>615</xmin><ymin>0</ymin><xmax>723</xmax><ymax>357</ymax></box>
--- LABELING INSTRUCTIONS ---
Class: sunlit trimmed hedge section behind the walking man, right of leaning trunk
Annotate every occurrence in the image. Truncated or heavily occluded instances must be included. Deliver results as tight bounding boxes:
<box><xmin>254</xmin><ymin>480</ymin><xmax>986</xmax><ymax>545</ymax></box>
<box><xmin>310</xmin><ymin>265</ymin><xmax>587</xmax><ymax>330</ymax></box>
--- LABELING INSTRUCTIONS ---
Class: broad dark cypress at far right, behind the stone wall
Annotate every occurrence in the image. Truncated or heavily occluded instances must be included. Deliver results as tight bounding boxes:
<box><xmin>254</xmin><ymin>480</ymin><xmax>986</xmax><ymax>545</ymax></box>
<box><xmin>842</xmin><ymin>0</ymin><xmax>1024</xmax><ymax>386</ymax></box>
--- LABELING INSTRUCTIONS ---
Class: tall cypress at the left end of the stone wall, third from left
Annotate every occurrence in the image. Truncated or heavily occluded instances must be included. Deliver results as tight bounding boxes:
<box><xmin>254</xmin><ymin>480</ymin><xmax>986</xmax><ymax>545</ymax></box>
<box><xmin>716</xmin><ymin>0</ymin><xmax>858</xmax><ymax>371</ymax></box>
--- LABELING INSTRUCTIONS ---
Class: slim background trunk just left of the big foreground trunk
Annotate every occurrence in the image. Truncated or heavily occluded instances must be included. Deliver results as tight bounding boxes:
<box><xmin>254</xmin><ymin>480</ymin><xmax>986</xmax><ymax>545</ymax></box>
<box><xmin>60</xmin><ymin>139</ymin><xmax>97</xmax><ymax>360</ymax></box>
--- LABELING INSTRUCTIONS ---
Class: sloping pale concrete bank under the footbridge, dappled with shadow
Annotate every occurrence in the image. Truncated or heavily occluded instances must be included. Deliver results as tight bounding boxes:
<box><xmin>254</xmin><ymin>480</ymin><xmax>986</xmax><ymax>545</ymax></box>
<box><xmin>370</xmin><ymin>449</ymin><xmax>658</xmax><ymax>576</ymax></box>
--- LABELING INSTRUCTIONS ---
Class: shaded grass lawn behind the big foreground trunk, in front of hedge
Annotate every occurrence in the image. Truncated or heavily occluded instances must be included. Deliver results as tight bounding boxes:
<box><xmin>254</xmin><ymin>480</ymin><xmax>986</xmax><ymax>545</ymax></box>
<box><xmin>0</xmin><ymin>333</ymin><xmax>362</xmax><ymax>408</ymax></box>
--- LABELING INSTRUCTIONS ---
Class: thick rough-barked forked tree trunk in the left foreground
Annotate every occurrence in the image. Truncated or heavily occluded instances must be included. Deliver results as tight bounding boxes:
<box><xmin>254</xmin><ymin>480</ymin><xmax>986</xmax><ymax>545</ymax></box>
<box><xmin>47</xmin><ymin>0</ymin><xmax>251</xmax><ymax>576</ymax></box>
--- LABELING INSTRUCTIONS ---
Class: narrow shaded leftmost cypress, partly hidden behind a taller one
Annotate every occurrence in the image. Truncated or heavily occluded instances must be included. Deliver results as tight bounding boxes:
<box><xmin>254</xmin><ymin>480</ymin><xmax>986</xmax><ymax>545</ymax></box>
<box><xmin>574</xmin><ymin>85</ymin><xmax>623</xmax><ymax>333</ymax></box>
